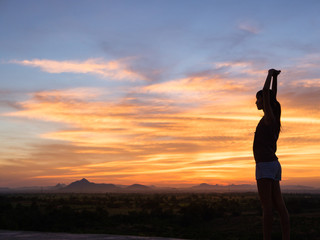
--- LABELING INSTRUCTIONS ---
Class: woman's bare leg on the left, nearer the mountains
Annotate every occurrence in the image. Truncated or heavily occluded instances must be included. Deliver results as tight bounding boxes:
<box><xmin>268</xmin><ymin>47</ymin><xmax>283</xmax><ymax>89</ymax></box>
<box><xmin>257</xmin><ymin>178</ymin><xmax>273</xmax><ymax>240</ymax></box>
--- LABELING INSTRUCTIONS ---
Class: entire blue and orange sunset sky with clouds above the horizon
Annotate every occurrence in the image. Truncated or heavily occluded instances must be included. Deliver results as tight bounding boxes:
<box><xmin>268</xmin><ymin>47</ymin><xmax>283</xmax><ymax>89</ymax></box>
<box><xmin>0</xmin><ymin>0</ymin><xmax>320</xmax><ymax>187</ymax></box>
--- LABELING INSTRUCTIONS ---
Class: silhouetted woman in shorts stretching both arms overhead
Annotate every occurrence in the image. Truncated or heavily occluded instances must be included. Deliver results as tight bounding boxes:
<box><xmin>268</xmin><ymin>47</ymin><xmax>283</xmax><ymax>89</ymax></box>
<box><xmin>253</xmin><ymin>69</ymin><xmax>290</xmax><ymax>240</ymax></box>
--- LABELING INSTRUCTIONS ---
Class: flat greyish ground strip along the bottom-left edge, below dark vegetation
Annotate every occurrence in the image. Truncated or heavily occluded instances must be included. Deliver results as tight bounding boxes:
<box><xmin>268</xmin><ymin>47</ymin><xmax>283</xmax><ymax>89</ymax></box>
<box><xmin>0</xmin><ymin>230</ymin><xmax>185</xmax><ymax>240</ymax></box>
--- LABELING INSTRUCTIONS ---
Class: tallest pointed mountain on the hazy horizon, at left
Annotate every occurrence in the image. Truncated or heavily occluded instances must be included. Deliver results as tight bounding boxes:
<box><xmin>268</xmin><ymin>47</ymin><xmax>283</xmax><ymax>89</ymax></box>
<box><xmin>61</xmin><ymin>178</ymin><xmax>120</xmax><ymax>193</ymax></box>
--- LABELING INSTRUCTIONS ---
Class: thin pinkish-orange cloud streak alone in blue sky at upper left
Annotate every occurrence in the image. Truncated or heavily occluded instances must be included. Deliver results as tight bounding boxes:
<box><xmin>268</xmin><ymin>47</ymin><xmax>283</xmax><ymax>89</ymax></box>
<box><xmin>10</xmin><ymin>58</ymin><xmax>144</xmax><ymax>80</ymax></box>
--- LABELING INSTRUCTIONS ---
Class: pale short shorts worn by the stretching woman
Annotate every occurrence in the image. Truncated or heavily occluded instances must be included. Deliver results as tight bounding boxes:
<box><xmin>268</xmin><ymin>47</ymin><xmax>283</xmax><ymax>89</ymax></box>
<box><xmin>256</xmin><ymin>161</ymin><xmax>281</xmax><ymax>181</ymax></box>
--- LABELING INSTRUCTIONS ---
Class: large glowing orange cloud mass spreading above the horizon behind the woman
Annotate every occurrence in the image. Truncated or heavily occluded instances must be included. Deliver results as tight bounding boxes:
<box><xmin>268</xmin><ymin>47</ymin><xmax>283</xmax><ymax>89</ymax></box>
<box><xmin>2</xmin><ymin>70</ymin><xmax>320</xmax><ymax>188</ymax></box>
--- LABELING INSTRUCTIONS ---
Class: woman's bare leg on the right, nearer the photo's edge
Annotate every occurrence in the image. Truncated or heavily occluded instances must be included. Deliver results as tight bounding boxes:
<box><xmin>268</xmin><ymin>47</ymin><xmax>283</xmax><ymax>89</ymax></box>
<box><xmin>272</xmin><ymin>181</ymin><xmax>290</xmax><ymax>240</ymax></box>
